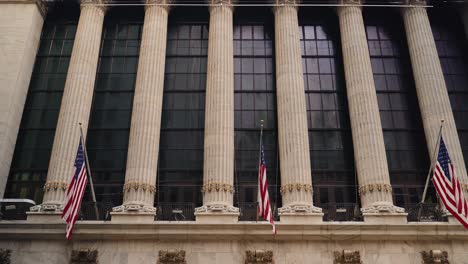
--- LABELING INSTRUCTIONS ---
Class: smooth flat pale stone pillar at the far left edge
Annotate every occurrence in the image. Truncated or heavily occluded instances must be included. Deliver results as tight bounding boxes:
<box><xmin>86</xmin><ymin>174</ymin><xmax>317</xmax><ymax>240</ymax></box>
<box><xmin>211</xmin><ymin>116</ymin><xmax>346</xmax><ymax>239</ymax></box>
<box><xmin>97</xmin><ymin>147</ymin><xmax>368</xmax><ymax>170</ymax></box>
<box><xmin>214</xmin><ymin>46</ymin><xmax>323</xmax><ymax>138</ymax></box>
<box><xmin>0</xmin><ymin>1</ymin><xmax>44</xmax><ymax>198</ymax></box>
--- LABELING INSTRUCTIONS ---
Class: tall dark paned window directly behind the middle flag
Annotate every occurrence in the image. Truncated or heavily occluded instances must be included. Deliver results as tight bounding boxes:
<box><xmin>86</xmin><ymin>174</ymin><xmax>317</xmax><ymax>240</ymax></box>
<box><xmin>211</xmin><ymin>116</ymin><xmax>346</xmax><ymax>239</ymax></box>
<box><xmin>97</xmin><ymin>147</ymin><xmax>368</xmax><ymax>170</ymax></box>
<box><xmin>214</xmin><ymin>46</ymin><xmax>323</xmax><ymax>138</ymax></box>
<box><xmin>234</xmin><ymin>8</ymin><xmax>281</xmax><ymax>220</ymax></box>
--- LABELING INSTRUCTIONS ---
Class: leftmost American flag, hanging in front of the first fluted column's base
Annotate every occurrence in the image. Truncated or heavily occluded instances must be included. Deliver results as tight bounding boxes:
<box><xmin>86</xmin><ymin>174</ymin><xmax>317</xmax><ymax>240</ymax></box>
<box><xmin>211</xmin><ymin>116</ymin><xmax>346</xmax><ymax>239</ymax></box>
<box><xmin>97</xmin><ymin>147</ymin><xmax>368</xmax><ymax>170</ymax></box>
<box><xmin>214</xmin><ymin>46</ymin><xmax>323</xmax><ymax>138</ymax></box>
<box><xmin>62</xmin><ymin>137</ymin><xmax>88</xmax><ymax>239</ymax></box>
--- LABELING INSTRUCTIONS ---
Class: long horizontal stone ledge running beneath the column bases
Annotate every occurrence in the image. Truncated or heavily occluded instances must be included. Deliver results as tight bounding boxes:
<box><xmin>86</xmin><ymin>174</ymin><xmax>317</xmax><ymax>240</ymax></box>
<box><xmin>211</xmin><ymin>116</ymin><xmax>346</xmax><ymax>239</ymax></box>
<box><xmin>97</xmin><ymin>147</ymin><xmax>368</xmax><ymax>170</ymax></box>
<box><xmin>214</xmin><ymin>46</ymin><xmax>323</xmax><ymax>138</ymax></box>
<box><xmin>0</xmin><ymin>221</ymin><xmax>462</xmax><ymax>241</ymax></box>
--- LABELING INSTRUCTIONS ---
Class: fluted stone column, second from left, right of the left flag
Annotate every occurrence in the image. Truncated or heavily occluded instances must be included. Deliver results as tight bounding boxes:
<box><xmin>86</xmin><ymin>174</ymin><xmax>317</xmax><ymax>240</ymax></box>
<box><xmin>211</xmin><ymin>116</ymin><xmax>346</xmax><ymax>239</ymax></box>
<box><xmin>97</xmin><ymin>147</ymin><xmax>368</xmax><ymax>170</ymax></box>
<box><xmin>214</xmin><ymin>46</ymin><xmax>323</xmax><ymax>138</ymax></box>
<box><xmin>112</xmin><ymin>0</ymin><xmax>170</xmax><ymax>221</ymax></box>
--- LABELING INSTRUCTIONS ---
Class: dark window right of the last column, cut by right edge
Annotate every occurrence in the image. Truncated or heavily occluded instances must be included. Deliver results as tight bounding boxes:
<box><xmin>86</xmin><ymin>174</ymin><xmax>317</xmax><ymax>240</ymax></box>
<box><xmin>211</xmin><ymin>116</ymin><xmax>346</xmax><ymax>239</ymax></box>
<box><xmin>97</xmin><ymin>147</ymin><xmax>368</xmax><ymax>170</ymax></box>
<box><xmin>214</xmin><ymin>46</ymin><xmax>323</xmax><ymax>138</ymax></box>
<box><xmin>430</xmin><ymin>9</ymin><xmax>468</xmax><ymax>171</ymax></box>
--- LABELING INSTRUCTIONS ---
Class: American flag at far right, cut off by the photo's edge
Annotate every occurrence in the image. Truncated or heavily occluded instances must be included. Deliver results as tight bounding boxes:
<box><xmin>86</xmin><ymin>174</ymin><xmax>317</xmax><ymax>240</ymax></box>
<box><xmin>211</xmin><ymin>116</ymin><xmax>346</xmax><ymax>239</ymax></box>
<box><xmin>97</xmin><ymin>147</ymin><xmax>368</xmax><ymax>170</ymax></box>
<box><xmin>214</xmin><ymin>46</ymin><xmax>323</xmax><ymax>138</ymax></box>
<box><xmin>432</xmin><ymin>137</ymin><xmax>468</xmax><ymax>229</ymax></box>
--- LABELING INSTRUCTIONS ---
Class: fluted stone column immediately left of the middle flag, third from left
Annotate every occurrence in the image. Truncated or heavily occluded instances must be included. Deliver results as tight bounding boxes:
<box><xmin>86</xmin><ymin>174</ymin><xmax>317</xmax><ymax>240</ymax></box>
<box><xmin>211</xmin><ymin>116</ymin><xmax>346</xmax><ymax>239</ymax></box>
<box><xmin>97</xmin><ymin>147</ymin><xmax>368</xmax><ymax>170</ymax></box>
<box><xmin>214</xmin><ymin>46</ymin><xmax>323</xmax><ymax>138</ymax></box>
<box><xmin>195</xmin><ymin>0</ymin><xmax>239</xmax><ymax>222</ymax></box>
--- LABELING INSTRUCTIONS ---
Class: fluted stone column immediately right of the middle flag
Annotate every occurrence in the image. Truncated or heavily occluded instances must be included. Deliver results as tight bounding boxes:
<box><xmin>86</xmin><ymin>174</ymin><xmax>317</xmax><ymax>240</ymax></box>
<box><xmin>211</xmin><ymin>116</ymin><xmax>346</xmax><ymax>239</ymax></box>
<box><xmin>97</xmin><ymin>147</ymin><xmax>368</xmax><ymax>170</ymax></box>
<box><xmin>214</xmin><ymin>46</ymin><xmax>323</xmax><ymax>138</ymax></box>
<box><xmin>274</xmin><ymin>0</ymin><xmax>323</xmax><ymax>223</ymax></box>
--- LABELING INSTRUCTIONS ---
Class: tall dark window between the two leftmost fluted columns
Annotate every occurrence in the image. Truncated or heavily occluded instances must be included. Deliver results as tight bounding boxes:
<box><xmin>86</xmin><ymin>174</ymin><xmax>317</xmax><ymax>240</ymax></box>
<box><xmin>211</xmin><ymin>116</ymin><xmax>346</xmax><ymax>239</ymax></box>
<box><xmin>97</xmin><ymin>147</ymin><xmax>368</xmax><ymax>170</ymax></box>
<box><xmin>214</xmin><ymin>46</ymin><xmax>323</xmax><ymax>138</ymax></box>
<box><xmin>85</xmin><ymin>9</ymin><xmax>143</xmax><ymax>205</ymax></box>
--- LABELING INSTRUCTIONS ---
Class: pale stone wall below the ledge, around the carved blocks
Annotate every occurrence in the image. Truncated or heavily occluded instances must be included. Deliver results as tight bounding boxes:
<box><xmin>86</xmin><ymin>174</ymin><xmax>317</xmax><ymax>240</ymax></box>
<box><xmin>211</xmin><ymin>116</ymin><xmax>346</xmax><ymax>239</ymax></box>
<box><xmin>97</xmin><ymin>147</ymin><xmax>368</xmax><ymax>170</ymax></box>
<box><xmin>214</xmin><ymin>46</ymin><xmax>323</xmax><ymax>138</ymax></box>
<box><xmin>0</xmin><ymin>234</ymin><xmax>468</xmax><ymax>264</ymax></box>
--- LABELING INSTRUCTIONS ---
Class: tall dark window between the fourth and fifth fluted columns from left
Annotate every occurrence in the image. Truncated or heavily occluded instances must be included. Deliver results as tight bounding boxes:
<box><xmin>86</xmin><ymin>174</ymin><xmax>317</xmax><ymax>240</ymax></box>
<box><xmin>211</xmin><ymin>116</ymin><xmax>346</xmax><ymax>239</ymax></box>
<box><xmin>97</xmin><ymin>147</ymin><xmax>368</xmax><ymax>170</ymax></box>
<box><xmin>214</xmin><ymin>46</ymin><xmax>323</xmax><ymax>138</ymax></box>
<box><xmin>299</xmin><ymin>9</ymin><xmax>357</xmax><ymax>207</ymax></box>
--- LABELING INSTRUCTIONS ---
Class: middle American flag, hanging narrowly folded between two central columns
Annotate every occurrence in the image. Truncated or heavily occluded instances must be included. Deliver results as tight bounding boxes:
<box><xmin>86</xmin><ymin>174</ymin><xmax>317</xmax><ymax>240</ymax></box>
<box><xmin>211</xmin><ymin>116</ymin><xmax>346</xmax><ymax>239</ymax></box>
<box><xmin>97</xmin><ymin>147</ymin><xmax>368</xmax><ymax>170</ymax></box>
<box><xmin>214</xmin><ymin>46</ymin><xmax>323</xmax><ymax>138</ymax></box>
<box><xmin>257</xmin><ymin>139</ymin><xmax>276</xmax><ymax>235</ymax></box>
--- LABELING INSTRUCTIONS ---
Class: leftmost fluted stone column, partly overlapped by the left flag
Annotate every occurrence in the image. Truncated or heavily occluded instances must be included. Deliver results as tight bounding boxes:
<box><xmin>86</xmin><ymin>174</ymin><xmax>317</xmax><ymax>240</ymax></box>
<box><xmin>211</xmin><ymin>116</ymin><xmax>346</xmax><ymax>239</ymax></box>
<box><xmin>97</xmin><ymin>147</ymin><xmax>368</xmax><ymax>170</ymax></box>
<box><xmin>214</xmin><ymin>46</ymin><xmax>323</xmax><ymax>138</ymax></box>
<box><xmin>29</xmin><ymin>0</ymin><xmax>105</xmax><ymax>218</ymax></box>
